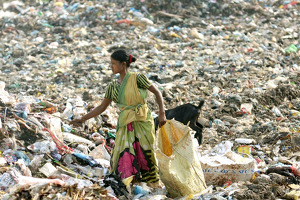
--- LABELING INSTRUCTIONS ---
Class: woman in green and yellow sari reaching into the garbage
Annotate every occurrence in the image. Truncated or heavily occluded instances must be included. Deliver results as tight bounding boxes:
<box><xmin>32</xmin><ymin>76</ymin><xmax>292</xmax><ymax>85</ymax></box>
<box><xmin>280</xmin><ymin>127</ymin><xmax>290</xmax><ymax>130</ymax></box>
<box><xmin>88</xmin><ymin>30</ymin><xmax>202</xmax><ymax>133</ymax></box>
<box><xmin>71</xmin><ymin>50</ymin><xmax>166</xmax><ymax>187</ymax></box>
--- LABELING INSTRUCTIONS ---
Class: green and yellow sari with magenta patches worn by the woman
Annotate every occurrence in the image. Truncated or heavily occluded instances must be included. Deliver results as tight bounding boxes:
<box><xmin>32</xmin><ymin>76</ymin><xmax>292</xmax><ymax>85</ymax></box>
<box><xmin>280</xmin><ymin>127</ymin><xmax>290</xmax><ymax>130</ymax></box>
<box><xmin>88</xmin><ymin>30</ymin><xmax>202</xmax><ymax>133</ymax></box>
<box><xmin>111</xmin><ymin>73</ymin><xmax>159</xmax><ymax>182</ymax></box>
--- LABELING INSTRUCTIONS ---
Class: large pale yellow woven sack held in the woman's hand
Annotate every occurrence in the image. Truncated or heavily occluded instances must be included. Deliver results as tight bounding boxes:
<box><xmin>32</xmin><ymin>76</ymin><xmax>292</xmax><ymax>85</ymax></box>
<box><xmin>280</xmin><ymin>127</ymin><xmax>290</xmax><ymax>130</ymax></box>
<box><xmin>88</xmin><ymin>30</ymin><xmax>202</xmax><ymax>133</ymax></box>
<box><xmin>156</xmin><ymin>120</ymin><xmax>206</xmax><ymax>198</ymax></box>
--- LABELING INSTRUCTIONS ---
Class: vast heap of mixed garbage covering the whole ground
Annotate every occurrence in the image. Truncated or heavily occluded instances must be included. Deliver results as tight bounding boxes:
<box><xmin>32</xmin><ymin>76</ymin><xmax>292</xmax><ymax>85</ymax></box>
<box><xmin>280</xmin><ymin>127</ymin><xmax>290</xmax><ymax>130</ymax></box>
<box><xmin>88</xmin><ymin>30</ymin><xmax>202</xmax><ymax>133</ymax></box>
<box><xmin>0</xmin><ymin>0</ymin><xmax>300</xmax><ymax>199</ymax></box>
